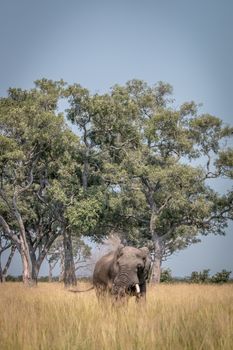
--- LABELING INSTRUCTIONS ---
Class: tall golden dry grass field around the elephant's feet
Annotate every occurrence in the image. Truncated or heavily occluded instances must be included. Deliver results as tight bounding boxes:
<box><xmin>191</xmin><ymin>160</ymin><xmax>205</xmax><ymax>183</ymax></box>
<box><xmin>0</xmin><ymin>283</ymin><xmax>233</xmax><ymax>350</ymax></box>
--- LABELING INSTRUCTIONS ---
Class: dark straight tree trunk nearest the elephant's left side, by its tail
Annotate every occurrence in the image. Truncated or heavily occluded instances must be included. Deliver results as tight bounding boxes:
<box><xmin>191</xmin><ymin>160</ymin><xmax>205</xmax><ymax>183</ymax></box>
<box><xmin>63</xmin><ymin>230</ymin><xmax>77</xmax><ymax>287</ymax></box>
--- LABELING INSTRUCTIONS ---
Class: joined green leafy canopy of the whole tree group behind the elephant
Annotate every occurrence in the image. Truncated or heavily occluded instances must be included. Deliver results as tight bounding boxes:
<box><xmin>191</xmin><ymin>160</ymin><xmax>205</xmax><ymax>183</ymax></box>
<box><xmin>0</xmin><ymin>79</ymin><xmax>233</xmax><ymax>281</ymax></box>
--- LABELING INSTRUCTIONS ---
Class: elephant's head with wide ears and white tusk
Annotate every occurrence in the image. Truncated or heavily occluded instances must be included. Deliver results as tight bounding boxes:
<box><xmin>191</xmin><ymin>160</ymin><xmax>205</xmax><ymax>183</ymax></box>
<box><xmin>113</xmin><ymin>245</ymin><xmax>150</xmax><ymax>295</ymax></box>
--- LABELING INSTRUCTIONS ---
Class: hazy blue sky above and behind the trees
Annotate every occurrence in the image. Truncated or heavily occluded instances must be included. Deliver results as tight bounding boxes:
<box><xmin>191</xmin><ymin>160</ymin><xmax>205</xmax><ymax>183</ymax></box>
<box><xmin>0</xmin><ymin>0</ymin><xmax>233</xmax><ymax>276</ymax></box>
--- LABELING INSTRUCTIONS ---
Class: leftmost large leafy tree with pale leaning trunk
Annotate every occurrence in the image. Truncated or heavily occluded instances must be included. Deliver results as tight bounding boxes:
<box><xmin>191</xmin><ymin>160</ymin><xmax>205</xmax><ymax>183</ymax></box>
<box><xmin>0</xmin><ymin>79</ymin><xmax>78</xmax><ymax>284</ymax></box>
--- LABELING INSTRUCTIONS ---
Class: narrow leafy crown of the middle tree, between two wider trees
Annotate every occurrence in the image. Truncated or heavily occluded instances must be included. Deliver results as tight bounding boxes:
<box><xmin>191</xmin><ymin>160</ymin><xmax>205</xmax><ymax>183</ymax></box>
<box><xmin>64</xmin><ymin>84</ymin><xmax>118</xmax><ymax>241</ymax></box>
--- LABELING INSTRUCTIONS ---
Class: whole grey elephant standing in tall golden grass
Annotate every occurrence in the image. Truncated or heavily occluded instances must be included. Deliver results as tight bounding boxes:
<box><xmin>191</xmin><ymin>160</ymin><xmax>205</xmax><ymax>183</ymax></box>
<box><xmin>93</xmin><ymin>245</ymin><xmax>151</xmax><ymax>300</ymax></box>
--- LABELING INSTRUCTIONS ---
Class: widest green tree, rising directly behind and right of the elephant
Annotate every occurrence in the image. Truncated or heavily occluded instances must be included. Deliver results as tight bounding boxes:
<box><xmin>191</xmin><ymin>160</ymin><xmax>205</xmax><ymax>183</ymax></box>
<box><xmin>66</xmin><ymin>80</ymin><xmax>233</xmax><ymax>283</ymax></box>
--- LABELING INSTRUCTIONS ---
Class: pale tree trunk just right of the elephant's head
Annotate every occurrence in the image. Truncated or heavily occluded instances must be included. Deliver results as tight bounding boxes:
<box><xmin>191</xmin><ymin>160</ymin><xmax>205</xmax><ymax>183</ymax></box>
<box><xmin>150</xmin><ymin>236</ymin><xmax>163</xmax><ymax>284</ymax></box>
